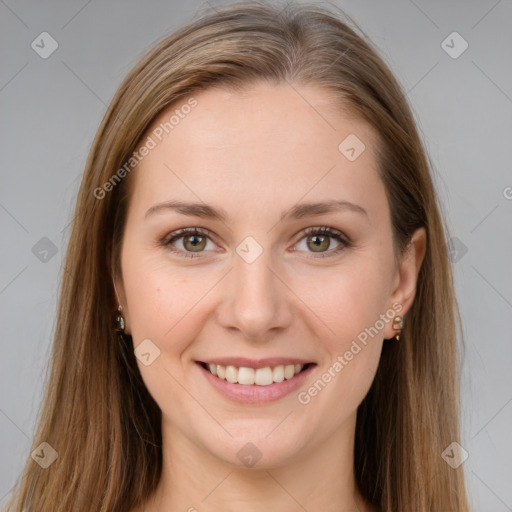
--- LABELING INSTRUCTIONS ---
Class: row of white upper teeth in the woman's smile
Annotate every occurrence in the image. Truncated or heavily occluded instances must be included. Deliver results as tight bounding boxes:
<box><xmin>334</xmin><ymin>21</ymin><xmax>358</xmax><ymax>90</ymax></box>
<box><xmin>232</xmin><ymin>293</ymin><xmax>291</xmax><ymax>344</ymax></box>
<box><xmin>203</xmin><ymin>364</ymin><xmax>304</xmax><ymax>386</ymax></box>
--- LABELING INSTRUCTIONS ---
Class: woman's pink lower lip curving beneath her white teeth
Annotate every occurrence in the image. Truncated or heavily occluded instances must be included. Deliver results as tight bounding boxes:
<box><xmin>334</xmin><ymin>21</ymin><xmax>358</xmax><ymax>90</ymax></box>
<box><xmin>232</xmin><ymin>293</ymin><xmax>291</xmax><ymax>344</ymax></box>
<box><xmin>196</xmin><ymin>363</ymin><xmax>316</xmax><ymax>404</ymax></box>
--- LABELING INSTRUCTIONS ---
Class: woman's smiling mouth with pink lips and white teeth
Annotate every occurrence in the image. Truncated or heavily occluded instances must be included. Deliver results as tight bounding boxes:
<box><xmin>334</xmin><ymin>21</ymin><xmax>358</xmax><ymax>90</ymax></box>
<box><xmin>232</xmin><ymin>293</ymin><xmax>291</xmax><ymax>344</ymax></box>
<box><xmin>196</xmin><ymin>360</ymin><xmax>317</xmax><ymax>404</ymax></box>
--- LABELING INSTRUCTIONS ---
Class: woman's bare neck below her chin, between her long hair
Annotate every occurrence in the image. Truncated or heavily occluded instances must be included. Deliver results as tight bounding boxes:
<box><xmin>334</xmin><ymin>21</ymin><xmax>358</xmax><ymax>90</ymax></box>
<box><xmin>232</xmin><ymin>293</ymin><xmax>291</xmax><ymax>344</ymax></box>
<box><xmin>144</xmin><ymin>416</ymin><xmax>374</xmax><ymax>512</ymax></box>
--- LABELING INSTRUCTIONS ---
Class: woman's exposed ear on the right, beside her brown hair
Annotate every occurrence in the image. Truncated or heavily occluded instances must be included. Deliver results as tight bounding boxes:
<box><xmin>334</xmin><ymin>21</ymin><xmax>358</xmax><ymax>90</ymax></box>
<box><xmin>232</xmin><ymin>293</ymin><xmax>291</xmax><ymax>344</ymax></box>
<box><xmin>384</xmin><ymin>228</ymin><xmax>427</xmax><ymax>339</ymax></box>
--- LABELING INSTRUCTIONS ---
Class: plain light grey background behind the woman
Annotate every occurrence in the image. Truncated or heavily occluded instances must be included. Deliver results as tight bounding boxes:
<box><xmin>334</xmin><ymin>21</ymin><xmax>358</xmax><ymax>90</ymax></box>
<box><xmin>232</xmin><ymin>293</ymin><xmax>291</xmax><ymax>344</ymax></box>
<box><xmin>0</xmin><ymin>0</ymin><xmax>512</xmax><ymax>512</ymax></box>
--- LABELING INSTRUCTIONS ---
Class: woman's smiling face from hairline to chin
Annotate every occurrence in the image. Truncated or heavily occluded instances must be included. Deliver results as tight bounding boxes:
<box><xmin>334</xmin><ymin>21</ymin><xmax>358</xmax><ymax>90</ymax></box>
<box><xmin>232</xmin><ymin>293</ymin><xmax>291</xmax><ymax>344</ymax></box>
<box><xmin>117</xmin><ymin>84</ymin><xmax>422</xmax><ymax>467</ymax></box>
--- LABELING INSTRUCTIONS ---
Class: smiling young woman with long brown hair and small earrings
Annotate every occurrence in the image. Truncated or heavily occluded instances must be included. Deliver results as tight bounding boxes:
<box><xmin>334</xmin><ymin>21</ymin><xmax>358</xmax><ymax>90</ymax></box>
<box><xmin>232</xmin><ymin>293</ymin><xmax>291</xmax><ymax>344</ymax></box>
<box><xmin>8</xmin><ymin>3</ymin><xmax>468</xmax><ymax>512</ymax></box>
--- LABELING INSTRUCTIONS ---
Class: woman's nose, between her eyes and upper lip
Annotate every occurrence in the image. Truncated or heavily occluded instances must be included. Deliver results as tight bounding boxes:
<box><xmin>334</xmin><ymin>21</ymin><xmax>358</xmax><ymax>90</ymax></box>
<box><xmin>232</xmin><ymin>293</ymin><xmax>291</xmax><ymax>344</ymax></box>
<box><xmin>217</xmin><ymin>246</ymin><xmax>293</xmax><ymax>343</ymax></box>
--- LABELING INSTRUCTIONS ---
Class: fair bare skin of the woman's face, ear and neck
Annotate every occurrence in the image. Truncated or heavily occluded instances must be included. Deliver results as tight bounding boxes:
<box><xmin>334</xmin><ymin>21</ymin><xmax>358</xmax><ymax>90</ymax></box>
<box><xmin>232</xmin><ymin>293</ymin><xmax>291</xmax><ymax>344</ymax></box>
<box><xmin>115</xmin><ymin>83</ymin><xmax>426</xmax><ymax>512</ymax></box>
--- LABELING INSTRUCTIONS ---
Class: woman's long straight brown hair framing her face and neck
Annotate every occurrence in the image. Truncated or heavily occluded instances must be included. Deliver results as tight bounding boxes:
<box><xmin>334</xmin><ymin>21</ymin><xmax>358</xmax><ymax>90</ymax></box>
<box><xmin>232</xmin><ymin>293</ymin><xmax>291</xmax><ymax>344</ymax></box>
<box><xmin>7</xmin><ymin>2</ymin><xmax>468</xmax><ymax>512</ymax></box>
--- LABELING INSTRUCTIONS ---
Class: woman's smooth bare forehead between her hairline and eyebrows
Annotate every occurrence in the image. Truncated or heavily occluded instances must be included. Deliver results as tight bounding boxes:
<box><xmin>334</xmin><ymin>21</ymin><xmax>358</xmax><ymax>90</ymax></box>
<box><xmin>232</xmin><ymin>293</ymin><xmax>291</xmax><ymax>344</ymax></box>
<box><xmin>127</xmin><ymin>83</ymin><xmax>383</xmax><ymax>221</ymax></box>
